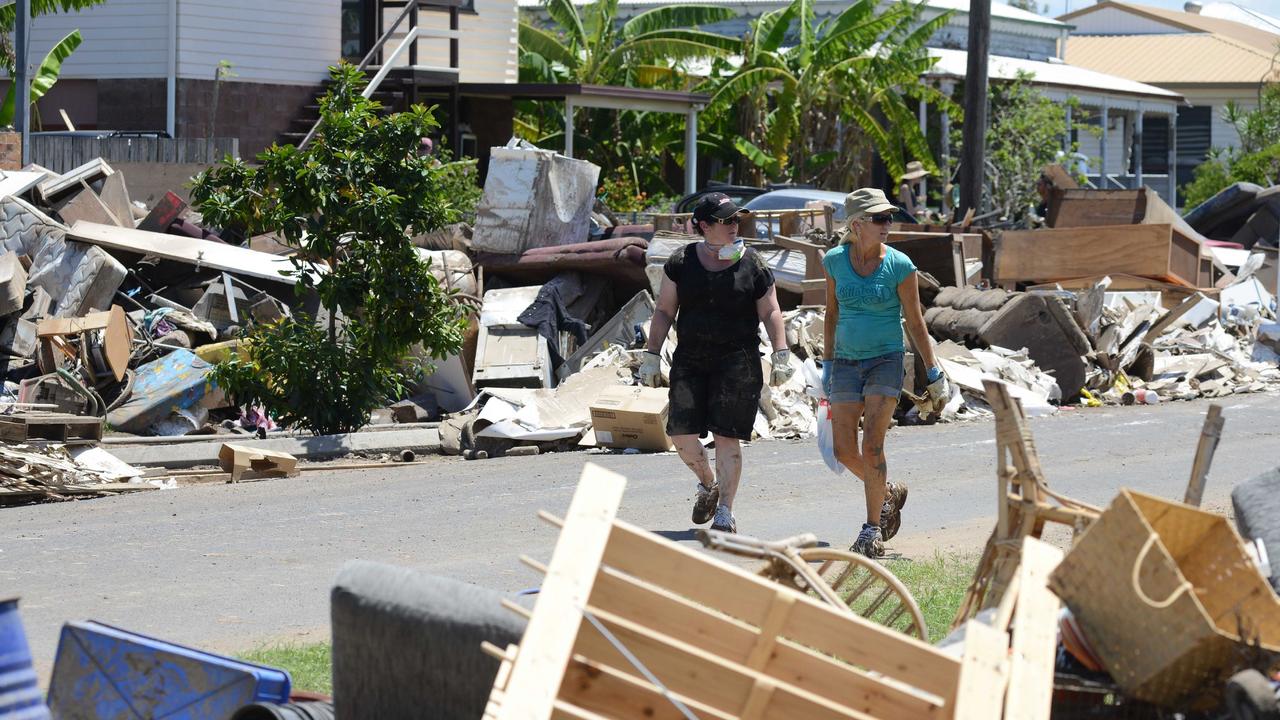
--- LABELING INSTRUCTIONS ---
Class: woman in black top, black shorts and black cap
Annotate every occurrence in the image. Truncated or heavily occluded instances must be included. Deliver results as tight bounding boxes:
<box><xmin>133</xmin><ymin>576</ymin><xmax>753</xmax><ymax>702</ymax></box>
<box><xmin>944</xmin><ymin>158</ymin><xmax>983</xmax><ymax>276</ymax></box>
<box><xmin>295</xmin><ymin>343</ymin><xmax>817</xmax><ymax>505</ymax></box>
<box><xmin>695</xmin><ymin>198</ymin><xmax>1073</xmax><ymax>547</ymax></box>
<box><xmin>640</xmin><ymin>192</ymin><xmax>795</xmax><ymax>533</ymax></box>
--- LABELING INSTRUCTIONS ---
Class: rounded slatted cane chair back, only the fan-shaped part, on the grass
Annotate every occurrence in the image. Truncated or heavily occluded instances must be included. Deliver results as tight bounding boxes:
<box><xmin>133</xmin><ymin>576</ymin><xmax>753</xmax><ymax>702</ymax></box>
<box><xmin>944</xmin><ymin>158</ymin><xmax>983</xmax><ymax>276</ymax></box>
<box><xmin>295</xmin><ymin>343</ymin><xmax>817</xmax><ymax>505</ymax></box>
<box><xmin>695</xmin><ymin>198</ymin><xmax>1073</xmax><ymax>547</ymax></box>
<box><xmin>797</xmin><ymin>547</ymin><xmax>929</xmax><ymax>642</ymax></box>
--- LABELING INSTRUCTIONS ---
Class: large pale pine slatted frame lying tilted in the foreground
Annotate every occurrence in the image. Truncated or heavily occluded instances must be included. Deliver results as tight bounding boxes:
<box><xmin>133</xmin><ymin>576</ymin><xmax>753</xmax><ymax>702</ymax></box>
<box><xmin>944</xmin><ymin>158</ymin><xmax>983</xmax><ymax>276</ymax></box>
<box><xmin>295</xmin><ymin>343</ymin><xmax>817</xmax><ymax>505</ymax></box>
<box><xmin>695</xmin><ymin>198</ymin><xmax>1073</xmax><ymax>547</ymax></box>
<box><xmin>485</xmin><ymin>464</ymin><xmax>1061</xmax><ymax>720</ymax></box>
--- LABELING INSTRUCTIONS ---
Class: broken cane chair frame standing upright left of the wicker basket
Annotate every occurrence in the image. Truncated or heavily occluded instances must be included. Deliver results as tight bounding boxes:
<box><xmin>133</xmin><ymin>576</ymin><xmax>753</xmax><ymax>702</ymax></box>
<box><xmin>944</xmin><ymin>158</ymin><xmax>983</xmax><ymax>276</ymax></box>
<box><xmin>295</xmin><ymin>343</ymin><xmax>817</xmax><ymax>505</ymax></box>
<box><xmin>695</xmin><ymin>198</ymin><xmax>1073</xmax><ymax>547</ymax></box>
<box><xmin>951</xmin><ymin>380</ymin><xmax>1101</xmax><ymax>628</ymax></box>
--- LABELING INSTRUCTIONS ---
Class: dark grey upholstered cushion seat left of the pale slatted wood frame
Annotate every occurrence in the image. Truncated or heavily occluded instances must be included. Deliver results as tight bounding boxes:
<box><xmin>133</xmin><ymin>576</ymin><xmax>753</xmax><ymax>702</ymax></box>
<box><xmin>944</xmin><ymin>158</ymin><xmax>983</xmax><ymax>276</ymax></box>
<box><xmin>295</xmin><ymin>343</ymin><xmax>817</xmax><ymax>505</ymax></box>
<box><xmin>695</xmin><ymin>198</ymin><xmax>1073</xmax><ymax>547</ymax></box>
<box><xmin>329</xmin><ymin>560</ymin><xmax>525</xmax><ymax>720</ymax></box>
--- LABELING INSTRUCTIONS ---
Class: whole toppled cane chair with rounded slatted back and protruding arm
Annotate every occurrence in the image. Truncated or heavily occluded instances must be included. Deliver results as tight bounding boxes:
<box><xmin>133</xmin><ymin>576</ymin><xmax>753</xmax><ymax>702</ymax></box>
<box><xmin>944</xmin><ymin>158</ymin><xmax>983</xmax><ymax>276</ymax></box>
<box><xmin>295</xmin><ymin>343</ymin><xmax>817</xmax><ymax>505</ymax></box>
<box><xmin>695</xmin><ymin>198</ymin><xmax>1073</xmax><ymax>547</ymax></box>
<box><xmin>694</xmin><ymin>528</ymin><xmax>929</xmax><ymax>642</ymax></box>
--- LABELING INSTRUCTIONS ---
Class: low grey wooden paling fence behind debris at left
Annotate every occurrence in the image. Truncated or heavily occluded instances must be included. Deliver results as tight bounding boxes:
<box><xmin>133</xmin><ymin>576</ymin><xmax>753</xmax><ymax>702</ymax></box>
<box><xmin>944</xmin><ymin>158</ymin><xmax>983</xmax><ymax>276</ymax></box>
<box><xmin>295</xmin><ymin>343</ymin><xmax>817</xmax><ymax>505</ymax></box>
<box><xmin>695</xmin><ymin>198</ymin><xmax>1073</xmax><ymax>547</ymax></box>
<box><xmin>31</xmin><ymin>136</ymin><xmax>239</xmax><ymax>173</ymax></box>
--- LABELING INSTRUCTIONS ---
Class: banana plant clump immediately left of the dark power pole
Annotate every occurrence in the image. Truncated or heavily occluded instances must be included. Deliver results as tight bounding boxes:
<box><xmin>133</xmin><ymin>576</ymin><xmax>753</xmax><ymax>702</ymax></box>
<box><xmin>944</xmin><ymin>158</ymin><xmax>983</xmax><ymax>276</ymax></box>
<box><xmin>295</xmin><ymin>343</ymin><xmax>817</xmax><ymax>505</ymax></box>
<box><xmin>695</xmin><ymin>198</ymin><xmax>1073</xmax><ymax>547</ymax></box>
<box><xmin>700</xmin><ymin>0</ymin><xmax>960</xmax><ymax>188</ymax></box>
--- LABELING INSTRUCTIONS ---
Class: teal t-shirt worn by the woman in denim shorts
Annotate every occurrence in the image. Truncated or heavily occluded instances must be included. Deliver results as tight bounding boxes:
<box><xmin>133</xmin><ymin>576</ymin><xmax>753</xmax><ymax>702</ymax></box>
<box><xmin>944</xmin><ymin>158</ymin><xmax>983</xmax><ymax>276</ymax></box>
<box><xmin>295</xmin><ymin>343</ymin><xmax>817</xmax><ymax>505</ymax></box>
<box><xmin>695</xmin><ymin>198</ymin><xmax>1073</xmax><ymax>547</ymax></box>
<box><xmin>822</xmin><ymin>245</ymin><xmax>915</xmax><ymax>360</ymax></box>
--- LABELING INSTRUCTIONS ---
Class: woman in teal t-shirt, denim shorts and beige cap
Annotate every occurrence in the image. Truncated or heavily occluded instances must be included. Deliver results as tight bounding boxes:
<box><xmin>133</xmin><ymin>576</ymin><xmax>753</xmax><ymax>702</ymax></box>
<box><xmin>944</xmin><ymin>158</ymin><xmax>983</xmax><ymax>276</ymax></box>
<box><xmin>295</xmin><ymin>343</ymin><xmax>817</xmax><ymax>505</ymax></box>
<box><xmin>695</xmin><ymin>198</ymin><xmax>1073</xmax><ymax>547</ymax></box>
<box><xmin>822</xmin><ymin>187</ymin><xmax>950</xmax><ymax>557</ymax></box>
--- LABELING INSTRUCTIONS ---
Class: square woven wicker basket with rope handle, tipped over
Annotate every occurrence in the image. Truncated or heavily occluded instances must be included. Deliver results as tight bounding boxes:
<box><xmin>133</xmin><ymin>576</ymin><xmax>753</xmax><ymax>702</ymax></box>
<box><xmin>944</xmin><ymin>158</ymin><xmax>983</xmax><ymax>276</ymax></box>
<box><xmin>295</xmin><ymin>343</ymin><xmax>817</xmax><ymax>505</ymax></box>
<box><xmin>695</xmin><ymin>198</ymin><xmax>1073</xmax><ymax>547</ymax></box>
<box><xmin>1050</xmin><ymin>489</ymin><xmax>1280</xmax><ymax>710</ymax></box>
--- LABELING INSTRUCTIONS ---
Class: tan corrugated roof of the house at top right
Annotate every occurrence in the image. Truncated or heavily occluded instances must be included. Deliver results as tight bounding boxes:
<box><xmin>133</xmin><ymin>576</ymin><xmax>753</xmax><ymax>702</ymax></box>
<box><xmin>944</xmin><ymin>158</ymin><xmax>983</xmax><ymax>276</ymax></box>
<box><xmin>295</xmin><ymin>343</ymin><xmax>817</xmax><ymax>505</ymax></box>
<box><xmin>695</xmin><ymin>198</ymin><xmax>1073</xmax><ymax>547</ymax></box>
<box><xmin>1064</xmin><ymin>32</ymin><xmax>1271</xmax><ymax>86</ymax></box>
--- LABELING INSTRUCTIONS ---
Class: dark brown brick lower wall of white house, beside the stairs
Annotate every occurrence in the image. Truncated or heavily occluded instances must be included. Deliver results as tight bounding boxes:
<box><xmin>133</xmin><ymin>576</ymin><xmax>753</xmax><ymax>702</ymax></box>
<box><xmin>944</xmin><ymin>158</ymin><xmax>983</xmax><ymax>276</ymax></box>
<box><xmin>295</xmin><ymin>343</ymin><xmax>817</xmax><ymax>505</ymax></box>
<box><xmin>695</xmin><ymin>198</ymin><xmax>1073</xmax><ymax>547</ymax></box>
<box><xmin>177</xmin><ymin>79</ymin><xmax>317</xmax><ymax>159</ymax></box>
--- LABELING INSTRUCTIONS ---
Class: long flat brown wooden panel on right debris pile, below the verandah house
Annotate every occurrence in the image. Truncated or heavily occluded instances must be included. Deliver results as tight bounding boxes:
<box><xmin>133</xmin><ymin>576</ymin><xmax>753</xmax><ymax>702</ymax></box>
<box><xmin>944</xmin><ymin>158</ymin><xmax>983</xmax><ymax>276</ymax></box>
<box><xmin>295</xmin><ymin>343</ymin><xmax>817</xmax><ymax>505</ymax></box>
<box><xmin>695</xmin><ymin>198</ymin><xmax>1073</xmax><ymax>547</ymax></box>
<box><xmin>996</xmin><ymin>224</ymin><xmax>1194</xmax><ymax>283</ymax></box>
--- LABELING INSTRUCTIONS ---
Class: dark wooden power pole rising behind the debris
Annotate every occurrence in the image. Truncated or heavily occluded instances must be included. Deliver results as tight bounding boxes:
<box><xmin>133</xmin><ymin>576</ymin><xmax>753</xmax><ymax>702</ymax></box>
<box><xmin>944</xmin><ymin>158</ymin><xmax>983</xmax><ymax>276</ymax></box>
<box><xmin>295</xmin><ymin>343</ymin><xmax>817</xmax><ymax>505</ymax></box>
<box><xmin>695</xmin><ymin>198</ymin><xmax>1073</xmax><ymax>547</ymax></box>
<box><xmin>956</xmin><ymin>0</ymin><xmax>991</xmax><ymax>217</ymax></box>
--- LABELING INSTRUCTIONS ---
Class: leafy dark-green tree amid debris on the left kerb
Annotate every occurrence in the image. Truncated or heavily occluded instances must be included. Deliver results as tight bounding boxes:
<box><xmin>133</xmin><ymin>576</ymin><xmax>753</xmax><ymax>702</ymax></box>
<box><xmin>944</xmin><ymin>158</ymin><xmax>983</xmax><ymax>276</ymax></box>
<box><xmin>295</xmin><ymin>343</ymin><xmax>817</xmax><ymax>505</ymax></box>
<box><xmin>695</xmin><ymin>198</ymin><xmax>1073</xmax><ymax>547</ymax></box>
<box><xmin>191</xmin><ymin>64</ymin><xmax>465</xmax><ymax>433</ymax></box>
